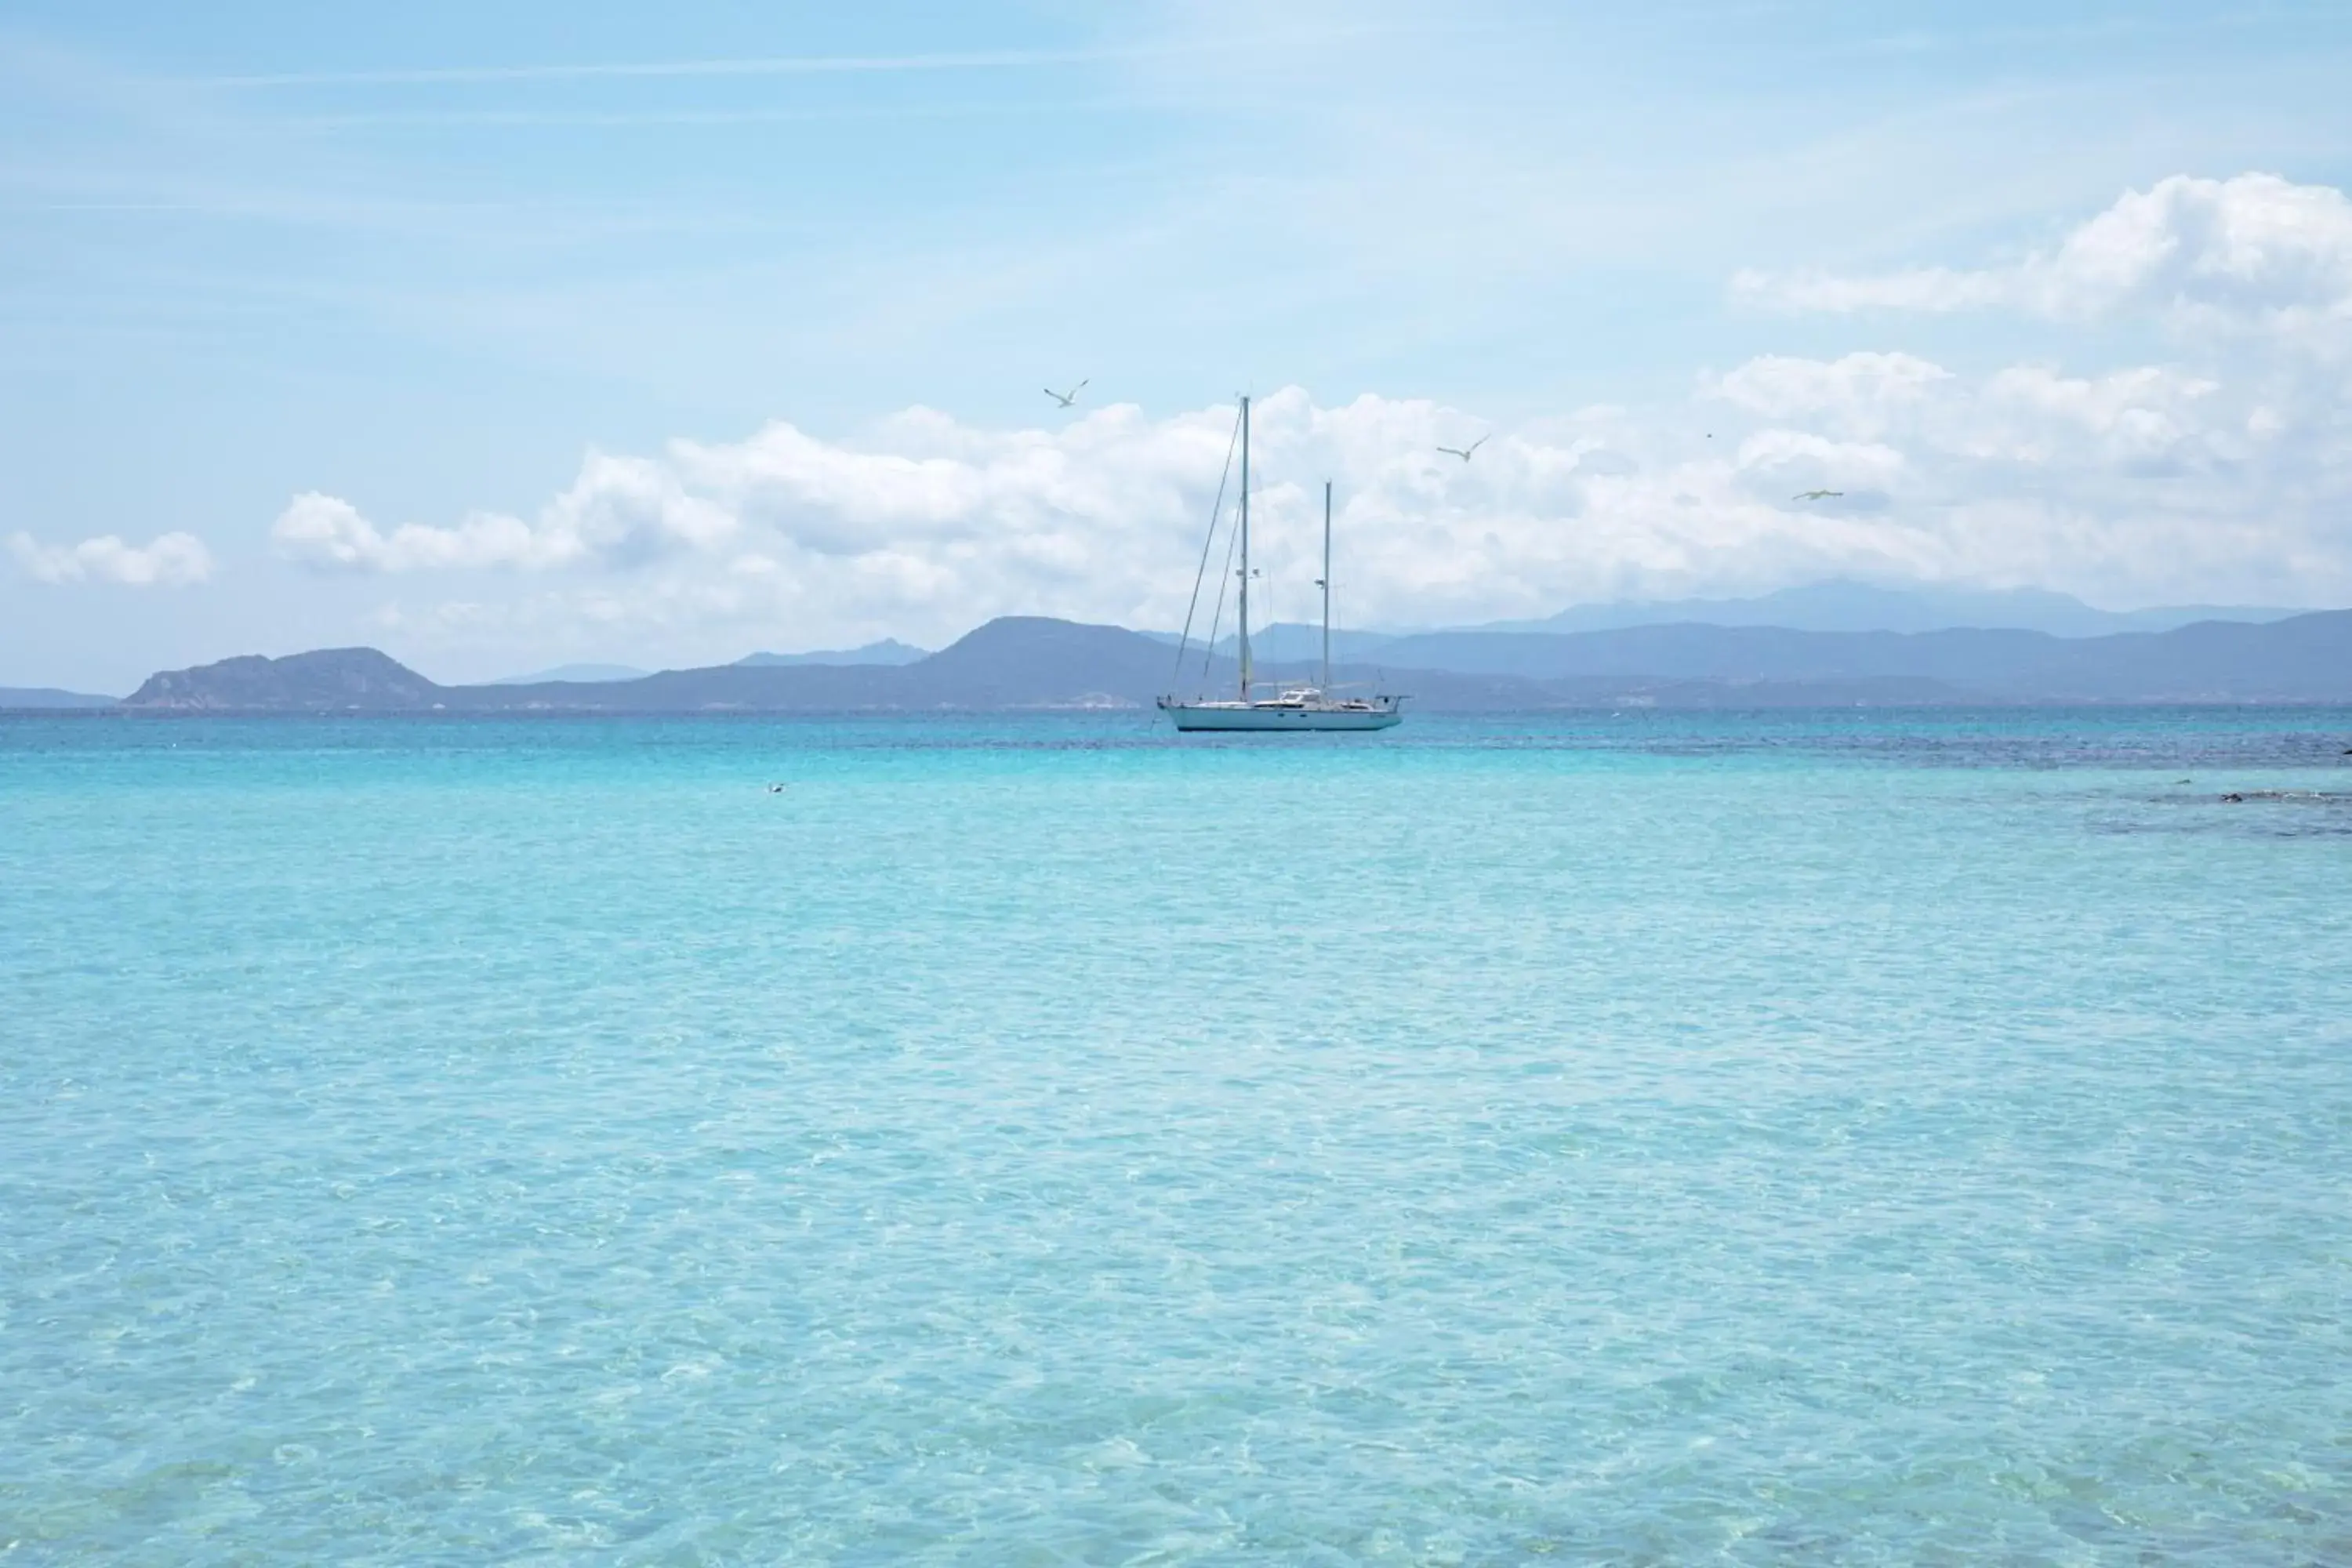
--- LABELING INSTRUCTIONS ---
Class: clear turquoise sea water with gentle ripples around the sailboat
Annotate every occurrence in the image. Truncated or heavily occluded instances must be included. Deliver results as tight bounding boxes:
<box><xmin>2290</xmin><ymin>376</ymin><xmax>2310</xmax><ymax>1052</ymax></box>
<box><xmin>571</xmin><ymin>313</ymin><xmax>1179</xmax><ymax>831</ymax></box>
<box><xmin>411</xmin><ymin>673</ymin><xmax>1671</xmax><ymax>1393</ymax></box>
<box><xmin>0</xmin><ymin>710</ymin><xmax>2352</xmax><ymax>1568</ymax></box>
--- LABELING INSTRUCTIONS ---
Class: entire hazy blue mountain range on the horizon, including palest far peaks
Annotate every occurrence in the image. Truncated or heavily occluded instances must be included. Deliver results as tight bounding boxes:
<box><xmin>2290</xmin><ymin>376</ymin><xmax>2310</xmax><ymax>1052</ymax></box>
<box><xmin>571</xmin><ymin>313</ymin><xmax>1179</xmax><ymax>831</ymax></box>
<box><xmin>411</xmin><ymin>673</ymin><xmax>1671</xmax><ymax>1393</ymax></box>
<box><xmin>13</xmin><ymin>583</ymin><xmax>2352</xmax><ymax>713</ymax></box>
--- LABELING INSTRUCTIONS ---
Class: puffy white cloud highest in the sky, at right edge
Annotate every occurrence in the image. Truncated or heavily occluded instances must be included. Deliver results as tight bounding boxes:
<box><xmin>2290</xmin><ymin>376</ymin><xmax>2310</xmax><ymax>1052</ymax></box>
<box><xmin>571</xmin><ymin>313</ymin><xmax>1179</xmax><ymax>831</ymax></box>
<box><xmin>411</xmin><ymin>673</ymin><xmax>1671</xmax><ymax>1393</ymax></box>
<box><xmin>1733</xmin><ymin>174</ymin><xmax>2352</xmax><ymax>329</ymax></box>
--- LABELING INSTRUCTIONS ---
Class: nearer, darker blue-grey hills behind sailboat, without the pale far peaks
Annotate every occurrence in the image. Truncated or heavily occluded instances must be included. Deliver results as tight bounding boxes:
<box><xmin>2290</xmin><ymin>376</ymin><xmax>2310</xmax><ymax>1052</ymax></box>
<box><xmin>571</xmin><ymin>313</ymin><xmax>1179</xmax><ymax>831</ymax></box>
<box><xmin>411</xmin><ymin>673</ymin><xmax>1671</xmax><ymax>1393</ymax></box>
<box><xmin>106</xmin><ymin>612</ymin><xmax>2352</xmax><ymax>713</ymax></box>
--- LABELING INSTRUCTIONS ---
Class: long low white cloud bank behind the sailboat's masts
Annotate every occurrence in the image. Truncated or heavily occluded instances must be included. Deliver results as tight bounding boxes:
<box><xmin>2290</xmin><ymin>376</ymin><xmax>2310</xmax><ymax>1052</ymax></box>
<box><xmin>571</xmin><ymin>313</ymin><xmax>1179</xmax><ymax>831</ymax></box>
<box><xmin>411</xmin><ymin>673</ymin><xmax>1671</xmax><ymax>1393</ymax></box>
<box><xmin>322</xmin><ymin>353</ymin><xmax>2352</xmax><ymax>656</ymax></box>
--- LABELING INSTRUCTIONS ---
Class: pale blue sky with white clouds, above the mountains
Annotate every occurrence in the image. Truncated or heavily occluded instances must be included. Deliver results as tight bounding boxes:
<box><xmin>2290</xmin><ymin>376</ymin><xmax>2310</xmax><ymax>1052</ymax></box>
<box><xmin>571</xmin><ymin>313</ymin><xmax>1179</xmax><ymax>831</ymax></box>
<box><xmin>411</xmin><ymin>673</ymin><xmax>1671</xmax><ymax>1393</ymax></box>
<box><xmin>0</xmin><ymin>0</ymin><xmax>2352</xmax><ymax>689</ymax></box>
